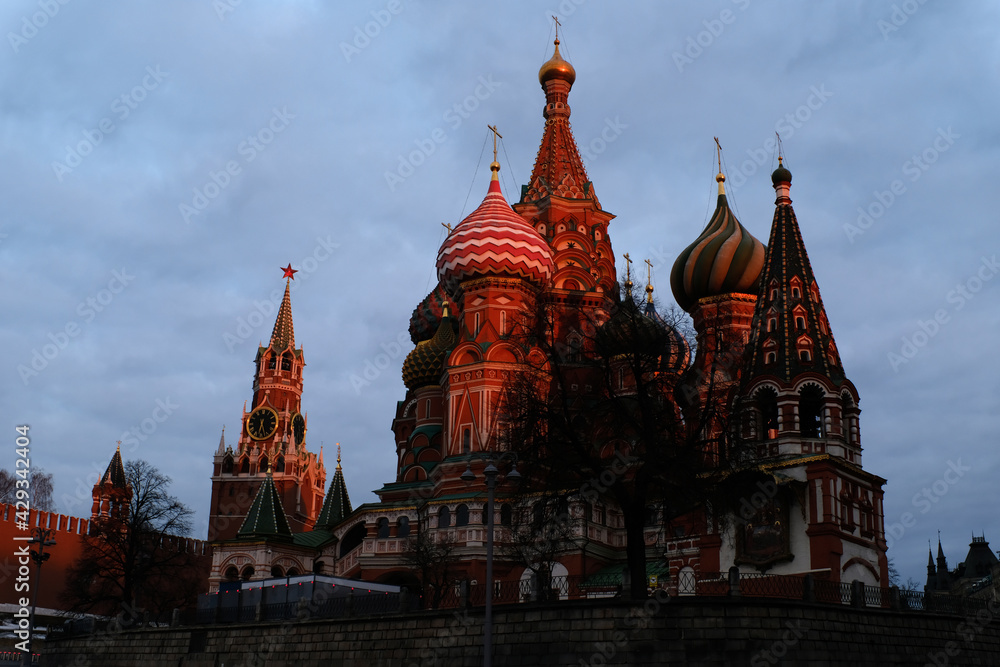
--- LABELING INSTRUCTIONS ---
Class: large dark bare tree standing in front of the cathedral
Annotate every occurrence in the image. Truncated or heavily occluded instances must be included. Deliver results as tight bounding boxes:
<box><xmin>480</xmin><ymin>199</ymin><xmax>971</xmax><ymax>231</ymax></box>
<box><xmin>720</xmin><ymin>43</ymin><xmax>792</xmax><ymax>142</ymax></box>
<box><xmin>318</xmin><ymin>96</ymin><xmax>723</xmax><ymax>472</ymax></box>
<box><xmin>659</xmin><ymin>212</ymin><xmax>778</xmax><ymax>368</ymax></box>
<box><xmin>502</xmin><ymin>284</ymin><xmax>752</xmax><ymax>598</ymax></box>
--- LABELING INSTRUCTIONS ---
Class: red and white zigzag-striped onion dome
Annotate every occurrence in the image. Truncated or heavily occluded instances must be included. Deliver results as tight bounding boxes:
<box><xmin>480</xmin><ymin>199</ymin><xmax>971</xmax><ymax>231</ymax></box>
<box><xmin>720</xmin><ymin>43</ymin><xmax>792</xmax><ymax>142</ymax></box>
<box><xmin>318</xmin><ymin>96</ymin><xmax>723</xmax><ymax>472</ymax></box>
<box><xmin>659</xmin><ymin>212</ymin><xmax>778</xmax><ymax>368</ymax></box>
<box><xmin>437</xmin><ymin>161</ymin><xmax>555</xmax><ymax>293</ymax></box>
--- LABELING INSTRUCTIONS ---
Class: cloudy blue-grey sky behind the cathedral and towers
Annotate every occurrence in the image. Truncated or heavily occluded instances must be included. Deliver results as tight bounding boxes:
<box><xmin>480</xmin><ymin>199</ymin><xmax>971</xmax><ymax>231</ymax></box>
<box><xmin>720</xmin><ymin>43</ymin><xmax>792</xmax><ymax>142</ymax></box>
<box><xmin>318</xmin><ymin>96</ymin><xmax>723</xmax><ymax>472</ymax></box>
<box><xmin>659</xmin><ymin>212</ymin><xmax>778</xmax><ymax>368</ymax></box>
<box><xmin>0</xmin><ymin>0</ymin><xmax>1000</xmax><ymax>581</ymax></box>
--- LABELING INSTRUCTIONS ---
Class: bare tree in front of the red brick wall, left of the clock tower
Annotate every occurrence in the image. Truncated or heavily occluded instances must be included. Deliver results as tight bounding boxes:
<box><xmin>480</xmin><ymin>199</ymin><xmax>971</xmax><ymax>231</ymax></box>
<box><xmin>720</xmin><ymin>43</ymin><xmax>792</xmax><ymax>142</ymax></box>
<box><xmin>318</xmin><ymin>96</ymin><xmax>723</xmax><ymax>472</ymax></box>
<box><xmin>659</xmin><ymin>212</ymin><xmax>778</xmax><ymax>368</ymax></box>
<box><xmin>63</xmin><ymin>460</ymin><xmax>203</xmax><ymax>617</ymax></box>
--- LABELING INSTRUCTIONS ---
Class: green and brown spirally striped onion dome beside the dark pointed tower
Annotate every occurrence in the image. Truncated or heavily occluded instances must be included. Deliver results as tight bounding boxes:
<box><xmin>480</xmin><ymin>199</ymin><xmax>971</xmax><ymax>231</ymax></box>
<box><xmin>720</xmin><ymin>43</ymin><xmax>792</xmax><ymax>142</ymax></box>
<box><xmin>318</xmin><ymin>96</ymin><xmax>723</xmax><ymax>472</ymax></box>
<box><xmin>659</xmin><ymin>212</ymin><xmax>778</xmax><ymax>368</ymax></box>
<box><xmin>670</xmin><ymin>173</ymin><xmax>765</xmax><ymax>312</ymax></box>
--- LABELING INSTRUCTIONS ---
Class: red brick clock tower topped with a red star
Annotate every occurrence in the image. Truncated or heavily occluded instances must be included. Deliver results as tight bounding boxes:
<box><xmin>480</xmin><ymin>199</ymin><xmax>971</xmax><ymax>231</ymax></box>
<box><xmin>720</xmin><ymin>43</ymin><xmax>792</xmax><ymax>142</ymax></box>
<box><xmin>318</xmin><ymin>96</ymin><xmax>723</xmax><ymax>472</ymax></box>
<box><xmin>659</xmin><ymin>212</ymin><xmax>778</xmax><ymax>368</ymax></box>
<box><xmin>208</xmin><ymin>265</ymin><xmax>326</xmax><ymax>542</ymax></box>
